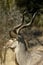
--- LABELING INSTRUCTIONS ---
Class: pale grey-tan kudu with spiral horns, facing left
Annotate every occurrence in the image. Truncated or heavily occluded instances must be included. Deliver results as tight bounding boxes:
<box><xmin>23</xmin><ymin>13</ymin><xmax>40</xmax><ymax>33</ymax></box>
<box><xmin>4</xmin><ymin>12</ymin><xmax>42</xmax><ymax>65</ymax></box>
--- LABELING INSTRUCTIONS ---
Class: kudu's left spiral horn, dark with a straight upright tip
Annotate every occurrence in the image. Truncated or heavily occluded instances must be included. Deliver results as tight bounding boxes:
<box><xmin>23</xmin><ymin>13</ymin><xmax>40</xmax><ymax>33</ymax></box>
<box><xmin>9</xmin><ymin>13</ymin><xmax>24</xmax><ymax>38</ymax></box>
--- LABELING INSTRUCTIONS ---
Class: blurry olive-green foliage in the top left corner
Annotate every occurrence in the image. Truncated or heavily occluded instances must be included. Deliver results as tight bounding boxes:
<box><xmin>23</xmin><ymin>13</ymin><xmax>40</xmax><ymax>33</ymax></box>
<box><xmin>0</xmin><ymin>0</ymin><xmax>13</xmax><ymax>11</ymax></box>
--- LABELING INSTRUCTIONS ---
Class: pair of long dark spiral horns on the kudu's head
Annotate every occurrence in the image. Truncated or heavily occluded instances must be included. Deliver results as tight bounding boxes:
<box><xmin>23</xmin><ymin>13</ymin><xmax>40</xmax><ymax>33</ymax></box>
<box><xmin>9</xmin><ymin>11</ymin><xmax>38</xmax><ymax>38</ymax></box>
